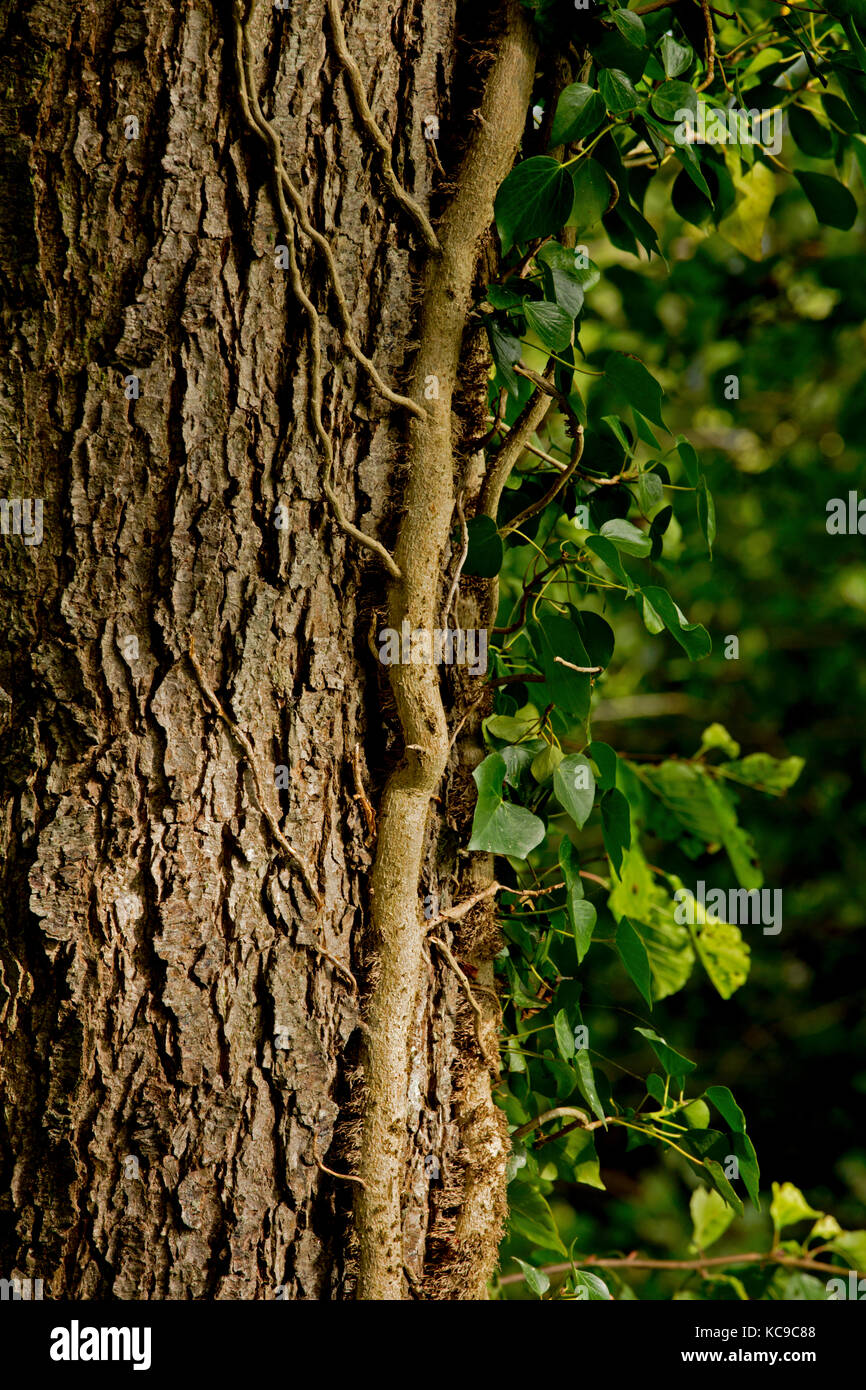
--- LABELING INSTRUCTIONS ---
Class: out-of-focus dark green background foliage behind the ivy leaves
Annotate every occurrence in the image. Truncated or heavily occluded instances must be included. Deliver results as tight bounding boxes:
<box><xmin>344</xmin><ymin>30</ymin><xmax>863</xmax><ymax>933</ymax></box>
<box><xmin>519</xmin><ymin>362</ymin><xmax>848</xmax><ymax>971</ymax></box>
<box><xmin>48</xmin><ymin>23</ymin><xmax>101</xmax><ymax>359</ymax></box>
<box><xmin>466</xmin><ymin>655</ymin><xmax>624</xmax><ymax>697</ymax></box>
<box><xmin>500</xmin><ymin>113</ymin><xmax>866</xmax><ymax>1298</ymax></box>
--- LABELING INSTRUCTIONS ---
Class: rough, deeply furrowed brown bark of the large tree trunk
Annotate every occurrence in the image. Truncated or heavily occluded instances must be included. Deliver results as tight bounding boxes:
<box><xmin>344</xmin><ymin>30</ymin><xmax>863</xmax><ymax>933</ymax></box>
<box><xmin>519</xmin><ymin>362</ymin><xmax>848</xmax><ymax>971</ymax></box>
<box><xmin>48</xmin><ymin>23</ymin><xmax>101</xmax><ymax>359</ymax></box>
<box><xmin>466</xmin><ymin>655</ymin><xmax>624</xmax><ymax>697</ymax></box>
<box><xmin>0</xmin><ymin>0</ymin><xmax>534</xmax><ymax>1300</ymax></box>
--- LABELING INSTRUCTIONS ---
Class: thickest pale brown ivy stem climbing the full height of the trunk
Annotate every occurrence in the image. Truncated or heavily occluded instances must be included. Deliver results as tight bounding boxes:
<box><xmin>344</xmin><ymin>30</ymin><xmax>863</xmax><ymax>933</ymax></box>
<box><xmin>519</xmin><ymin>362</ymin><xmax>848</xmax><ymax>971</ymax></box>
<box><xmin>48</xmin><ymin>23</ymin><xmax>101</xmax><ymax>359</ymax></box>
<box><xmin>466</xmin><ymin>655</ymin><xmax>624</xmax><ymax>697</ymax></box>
<box><xmin>356</xmin><ymin>0</ymin><xmax>537</xmax><ymax>1300</ymax></box>
